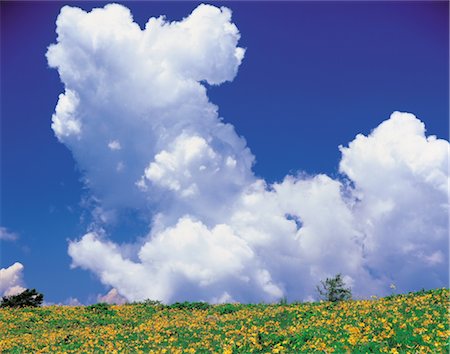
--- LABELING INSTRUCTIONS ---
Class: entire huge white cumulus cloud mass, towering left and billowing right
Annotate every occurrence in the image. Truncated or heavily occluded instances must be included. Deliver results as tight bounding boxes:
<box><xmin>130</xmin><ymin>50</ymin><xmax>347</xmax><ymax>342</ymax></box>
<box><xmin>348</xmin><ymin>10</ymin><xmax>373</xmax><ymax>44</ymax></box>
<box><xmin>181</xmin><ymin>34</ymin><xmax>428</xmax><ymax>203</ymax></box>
<box><xmin>47</xmin><ymin>4</ymin><xmax>448</xmax><ymax>302</ymax></box>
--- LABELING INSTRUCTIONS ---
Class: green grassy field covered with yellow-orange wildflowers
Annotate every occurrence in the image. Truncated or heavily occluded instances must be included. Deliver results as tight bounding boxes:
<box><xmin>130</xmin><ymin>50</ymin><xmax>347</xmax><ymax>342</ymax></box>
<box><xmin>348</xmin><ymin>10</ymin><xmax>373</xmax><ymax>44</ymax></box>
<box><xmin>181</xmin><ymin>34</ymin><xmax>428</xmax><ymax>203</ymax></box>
<box><xmin>0</xmin><ymin>289</ymin><xmax>450</xmax><ymax>353</ymax></box>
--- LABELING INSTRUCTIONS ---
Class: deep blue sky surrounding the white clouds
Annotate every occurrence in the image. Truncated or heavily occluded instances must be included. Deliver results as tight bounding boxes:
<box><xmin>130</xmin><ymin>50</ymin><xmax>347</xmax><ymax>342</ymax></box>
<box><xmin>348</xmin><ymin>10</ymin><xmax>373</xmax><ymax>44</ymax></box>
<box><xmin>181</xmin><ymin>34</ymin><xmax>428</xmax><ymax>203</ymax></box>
<box><xmin>0</xmin><ymin>1</ymin><xmax>449</xmax><ymax>303</ymax></box>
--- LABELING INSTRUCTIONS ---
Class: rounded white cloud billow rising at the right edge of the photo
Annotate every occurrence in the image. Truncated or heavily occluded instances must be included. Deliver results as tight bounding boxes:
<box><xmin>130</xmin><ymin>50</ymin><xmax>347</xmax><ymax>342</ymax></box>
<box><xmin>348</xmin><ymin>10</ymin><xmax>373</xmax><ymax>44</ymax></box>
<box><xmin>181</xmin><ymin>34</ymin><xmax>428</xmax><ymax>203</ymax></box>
<box><xmin>340</xmin><ymin>112</ymin><xmax>449</xmax><ymax>289</ymax></box>
